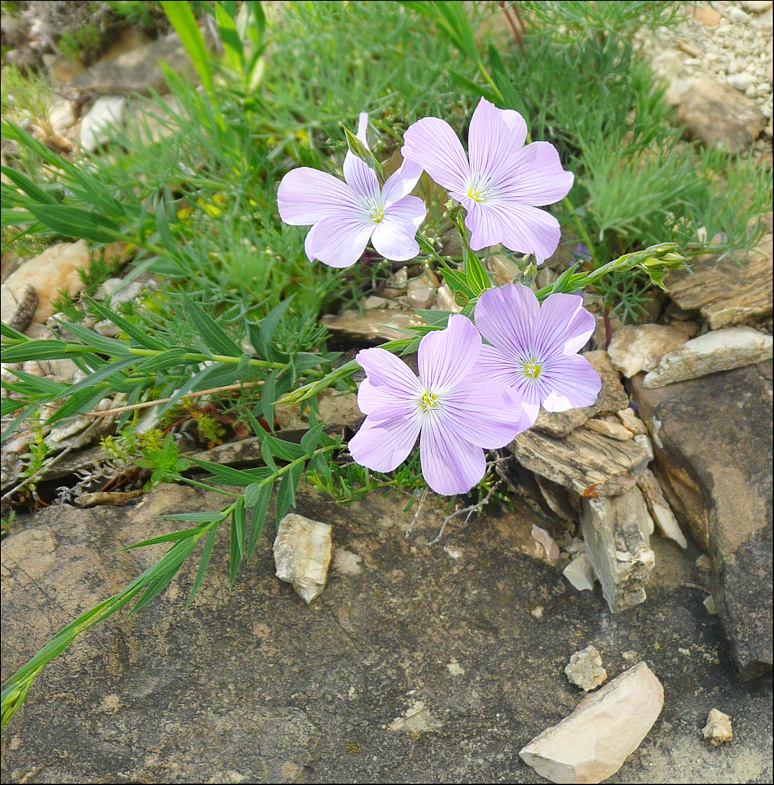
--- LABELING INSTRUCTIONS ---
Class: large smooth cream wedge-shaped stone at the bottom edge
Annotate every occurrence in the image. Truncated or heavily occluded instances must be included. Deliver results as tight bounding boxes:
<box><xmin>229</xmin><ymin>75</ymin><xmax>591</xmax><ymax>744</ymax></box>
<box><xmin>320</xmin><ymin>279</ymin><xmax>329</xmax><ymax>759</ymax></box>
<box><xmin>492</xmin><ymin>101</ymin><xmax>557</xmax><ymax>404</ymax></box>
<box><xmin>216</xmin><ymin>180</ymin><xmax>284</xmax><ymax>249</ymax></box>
<box><xmin>519</xmin><ymin>662</ymin><xmax>664</xmax><ymax>783</ymax></box>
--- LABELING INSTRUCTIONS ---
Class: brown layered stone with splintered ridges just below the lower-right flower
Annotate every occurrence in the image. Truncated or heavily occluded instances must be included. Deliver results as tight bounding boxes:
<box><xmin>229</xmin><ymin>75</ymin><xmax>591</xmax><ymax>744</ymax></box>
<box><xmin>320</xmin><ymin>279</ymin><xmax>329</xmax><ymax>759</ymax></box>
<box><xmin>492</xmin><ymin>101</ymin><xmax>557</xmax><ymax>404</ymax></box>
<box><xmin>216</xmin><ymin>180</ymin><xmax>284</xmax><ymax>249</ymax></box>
<box><xmin>510</xmin><ymin>428</ymin><xmax>651</xmax><ymax>498</ymax></box>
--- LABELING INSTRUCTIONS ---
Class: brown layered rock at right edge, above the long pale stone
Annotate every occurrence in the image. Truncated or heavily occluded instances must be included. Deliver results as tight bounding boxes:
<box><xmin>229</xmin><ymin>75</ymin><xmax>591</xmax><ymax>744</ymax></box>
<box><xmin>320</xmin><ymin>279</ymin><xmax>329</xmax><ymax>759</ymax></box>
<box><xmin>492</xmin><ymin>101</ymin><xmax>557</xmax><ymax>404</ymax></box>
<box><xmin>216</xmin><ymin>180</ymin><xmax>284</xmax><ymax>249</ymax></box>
<box><xmin>666</xmin><ymin>233</ymin><xmax>774</xmax><ymax>330</ymax></box>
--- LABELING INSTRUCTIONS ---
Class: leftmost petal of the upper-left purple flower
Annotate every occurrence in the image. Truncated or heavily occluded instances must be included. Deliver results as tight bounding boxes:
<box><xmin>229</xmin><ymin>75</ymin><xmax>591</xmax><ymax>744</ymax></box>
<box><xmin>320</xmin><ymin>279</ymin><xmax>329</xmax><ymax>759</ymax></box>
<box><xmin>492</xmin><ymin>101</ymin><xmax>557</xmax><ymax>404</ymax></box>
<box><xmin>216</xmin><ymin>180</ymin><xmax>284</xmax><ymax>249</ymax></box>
<box><xmin>277</xmin><ymin>166</ymin><xmax>357</xmax><ymax>226</ymax></box>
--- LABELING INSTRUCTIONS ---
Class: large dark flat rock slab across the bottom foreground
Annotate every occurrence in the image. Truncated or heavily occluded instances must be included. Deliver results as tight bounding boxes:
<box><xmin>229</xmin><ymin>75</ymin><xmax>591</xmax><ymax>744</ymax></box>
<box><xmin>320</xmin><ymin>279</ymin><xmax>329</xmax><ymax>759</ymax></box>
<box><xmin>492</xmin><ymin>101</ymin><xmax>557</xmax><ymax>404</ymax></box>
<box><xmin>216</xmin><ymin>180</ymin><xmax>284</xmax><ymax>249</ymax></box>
<box><xmin>2</xmin><ymin>487</ymin><xmax>774</xmax><ymax>783</ymax></box>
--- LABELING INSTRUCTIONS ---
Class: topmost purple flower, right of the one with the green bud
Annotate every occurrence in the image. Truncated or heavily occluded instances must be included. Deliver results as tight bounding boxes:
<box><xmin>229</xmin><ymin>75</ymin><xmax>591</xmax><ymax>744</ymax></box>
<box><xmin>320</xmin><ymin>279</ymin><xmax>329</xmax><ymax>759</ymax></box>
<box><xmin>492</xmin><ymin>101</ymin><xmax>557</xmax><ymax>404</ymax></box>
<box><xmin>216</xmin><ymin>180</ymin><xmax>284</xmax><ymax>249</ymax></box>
<box><xmin>401</xmin><ymin>98</ymin><xmax>574</xmax><ymax>264</ymax></box>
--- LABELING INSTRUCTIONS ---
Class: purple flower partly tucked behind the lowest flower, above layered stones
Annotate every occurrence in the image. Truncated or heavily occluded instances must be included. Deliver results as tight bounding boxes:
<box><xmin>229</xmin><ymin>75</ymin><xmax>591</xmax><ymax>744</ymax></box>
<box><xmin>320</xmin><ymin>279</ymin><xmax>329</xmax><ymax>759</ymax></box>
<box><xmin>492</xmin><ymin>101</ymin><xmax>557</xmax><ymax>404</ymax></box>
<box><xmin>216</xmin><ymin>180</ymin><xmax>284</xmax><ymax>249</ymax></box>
<box><xmin>476</xmin><ymin>284</ymin><xmax>602</xmax><ymax>425</ymax></box>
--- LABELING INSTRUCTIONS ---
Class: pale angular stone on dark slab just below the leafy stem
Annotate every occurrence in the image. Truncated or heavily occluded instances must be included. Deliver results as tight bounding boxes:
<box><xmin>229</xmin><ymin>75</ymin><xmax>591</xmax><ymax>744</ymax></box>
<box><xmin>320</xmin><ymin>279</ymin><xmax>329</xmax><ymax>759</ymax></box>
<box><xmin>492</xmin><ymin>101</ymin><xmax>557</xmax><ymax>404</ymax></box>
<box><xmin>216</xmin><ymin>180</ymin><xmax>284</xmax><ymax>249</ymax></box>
<box><xmin>274</xmin><ymin>513</ymin><xmax>333</xmax><ymax>605</ymax></box>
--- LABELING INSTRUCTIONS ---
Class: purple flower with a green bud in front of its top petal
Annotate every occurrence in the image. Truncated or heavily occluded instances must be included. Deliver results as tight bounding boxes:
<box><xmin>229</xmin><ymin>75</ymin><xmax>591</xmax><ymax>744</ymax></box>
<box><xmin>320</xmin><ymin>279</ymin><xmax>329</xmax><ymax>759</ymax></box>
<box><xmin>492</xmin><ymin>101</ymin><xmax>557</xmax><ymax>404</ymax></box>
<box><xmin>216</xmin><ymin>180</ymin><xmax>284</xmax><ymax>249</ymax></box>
<box><xmin>277</xmin><ymin>112</ymin><xmax>427</xmax><ymax>267</ymax></box>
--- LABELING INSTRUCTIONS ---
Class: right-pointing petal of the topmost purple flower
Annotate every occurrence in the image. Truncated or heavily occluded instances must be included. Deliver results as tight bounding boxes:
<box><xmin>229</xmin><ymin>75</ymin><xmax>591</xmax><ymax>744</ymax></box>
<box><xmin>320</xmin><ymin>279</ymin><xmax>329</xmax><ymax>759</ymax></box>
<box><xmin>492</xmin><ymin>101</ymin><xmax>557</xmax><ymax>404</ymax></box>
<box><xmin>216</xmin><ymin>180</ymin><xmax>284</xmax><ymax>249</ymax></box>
<box><xmin>497</xmin><ymin>142</ymin><xmax>575</xmax><ymax>206</ymax></box>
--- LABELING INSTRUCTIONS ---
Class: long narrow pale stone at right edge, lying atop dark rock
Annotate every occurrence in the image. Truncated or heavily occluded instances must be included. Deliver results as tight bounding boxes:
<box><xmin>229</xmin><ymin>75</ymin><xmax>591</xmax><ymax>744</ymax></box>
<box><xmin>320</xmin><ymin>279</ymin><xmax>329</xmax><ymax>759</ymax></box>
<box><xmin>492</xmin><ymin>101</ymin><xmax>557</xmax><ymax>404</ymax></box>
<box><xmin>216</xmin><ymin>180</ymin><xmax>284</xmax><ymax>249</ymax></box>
<box><xmin>642</xmin><ymin>327</ymin><xmax>774</xmax><ymax>389</ymax></box>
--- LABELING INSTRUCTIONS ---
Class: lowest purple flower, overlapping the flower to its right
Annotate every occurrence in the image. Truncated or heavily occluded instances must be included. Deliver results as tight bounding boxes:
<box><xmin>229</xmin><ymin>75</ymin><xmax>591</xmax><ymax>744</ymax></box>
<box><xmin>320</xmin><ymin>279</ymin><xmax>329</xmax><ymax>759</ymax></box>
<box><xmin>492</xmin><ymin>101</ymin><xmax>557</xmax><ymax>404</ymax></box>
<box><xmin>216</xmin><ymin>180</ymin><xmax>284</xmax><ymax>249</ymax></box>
<box><xmin>349</xmin><ymin>315</ymin><xmax>527</xmax><ymax>496</ymax></box>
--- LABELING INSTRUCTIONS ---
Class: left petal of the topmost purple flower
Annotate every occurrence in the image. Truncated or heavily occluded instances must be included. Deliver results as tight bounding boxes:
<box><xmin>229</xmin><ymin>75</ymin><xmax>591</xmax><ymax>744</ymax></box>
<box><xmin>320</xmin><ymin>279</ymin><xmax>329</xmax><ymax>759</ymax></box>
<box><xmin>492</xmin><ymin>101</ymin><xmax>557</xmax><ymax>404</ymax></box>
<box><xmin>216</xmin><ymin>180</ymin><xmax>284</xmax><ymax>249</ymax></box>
<box><xmin>400</xmin><ymin>117</ymin><xmax>470</xmax><ymax>191</ymax></box>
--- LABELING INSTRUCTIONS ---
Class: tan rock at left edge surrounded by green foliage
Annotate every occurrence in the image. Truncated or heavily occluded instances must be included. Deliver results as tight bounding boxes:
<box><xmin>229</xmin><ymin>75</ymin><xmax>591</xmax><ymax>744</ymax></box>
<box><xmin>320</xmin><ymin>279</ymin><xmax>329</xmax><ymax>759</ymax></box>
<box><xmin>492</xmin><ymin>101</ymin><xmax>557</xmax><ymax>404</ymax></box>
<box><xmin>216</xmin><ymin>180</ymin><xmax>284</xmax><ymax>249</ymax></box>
<box><xmin>5</xmin><ymin>240</ymin><xmax>90</xmax><ymax>324</ymax></box>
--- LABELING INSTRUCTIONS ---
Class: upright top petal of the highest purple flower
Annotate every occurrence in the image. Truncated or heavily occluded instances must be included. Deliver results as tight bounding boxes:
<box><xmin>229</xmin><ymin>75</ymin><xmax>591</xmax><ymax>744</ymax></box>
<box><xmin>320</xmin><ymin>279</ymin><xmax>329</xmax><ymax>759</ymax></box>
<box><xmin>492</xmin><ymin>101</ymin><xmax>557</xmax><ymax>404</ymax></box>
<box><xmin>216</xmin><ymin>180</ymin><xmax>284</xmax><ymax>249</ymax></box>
<box><xmin>468</xmin><ymin>98</ymin><xmax>527</xmax><ymax>183</ymax></box>
